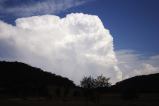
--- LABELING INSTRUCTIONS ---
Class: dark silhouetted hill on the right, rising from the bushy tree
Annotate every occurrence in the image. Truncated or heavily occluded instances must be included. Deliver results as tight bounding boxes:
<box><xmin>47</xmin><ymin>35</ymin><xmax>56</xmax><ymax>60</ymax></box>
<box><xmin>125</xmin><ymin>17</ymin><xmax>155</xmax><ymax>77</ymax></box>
<box><xmin>112</xmin><ymin>73</ymin><xmax>159</xmax><ymax>92</ymax></box>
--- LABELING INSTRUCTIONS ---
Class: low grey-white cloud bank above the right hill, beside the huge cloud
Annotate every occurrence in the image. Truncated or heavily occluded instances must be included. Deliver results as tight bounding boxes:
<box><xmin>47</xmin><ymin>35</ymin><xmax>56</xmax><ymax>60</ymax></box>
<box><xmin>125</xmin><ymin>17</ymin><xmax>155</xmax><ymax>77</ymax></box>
<box><xmin>116</xmin><ymin>50</ymin><xmax>159</xmax><ymax>79</ymax></box>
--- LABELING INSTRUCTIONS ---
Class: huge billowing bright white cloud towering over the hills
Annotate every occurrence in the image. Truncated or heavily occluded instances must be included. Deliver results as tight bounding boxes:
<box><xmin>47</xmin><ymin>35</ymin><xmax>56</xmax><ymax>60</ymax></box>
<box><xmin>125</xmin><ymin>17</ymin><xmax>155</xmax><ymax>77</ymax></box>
<box><xmin>0</xmin><ymin>13</ymin><xmax>122</xmax><ymax>84</ymax></box>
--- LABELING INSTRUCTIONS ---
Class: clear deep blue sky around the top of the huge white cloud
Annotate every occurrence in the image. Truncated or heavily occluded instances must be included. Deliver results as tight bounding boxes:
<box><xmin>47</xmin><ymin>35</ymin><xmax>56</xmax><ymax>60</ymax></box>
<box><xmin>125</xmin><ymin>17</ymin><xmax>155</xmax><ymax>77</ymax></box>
<box><xmin>0</xmin><ymin>0</ymin><xmax>159</xmax><ymax>55</ymax></box>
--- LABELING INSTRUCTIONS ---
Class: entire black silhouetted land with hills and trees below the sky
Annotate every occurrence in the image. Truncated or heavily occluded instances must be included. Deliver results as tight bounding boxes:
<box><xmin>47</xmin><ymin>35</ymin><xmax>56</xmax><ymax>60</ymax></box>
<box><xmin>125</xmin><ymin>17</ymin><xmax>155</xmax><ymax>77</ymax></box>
<box><xmin>0</xmin><ymin>62</ymin><xmax>159</xmax><ymax>106</ymax></box>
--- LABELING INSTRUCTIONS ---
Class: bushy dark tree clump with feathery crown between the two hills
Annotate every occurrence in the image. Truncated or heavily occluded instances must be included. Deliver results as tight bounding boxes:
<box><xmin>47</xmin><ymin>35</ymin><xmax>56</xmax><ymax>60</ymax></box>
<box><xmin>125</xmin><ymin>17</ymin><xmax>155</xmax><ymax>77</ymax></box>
<box><xmin>81</xmin><ymin>75</ymin><xmax>111</xmax><ymax>88</ymax></box>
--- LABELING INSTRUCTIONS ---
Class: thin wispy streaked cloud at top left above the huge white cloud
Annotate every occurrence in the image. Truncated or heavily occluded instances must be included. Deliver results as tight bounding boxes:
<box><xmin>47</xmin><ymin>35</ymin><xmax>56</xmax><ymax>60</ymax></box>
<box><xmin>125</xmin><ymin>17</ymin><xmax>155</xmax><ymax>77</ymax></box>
<box><xmin>0</xmin><ymin>0</ymin><xmax>89</xmax><ymax>17</ymax></box>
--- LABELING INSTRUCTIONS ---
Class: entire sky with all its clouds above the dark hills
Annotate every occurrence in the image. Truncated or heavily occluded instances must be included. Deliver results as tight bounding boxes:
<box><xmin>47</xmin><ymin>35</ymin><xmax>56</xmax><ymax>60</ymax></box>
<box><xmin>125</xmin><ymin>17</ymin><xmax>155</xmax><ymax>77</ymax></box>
<box><xmin>0</xmin><ymin>0</ymin><xmax>159</xmax><ymax>84</ymax></box>
